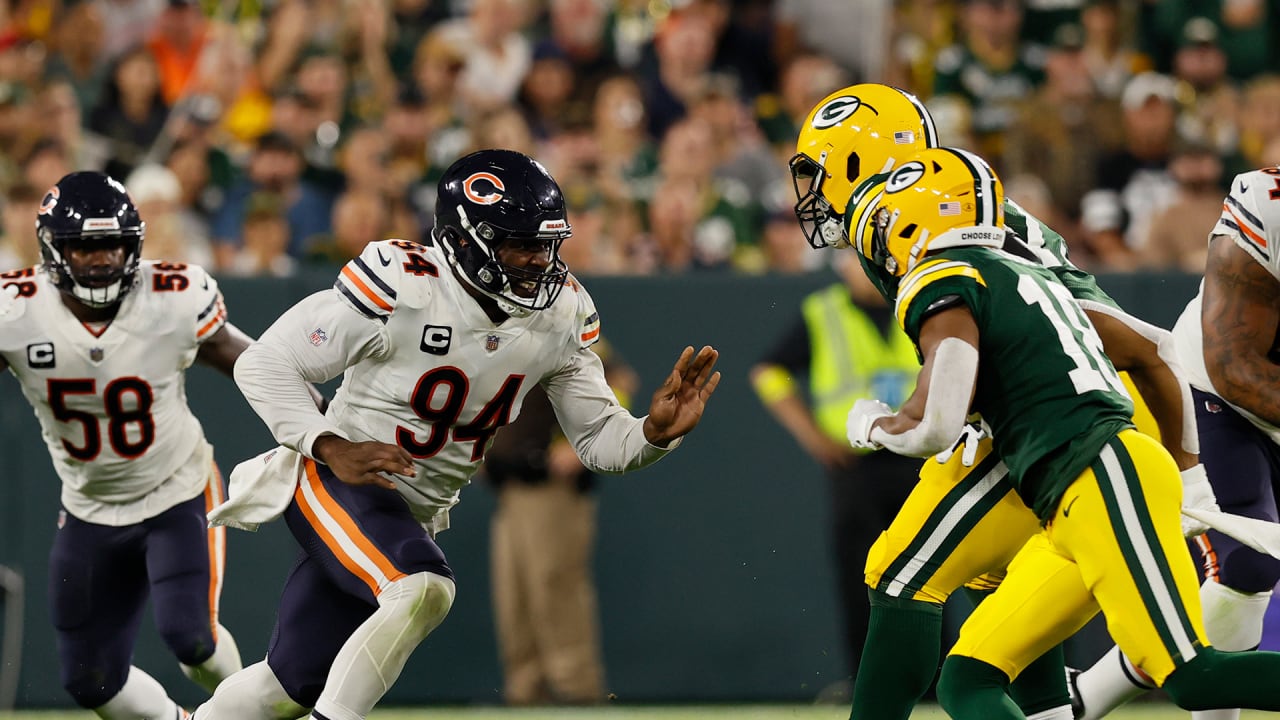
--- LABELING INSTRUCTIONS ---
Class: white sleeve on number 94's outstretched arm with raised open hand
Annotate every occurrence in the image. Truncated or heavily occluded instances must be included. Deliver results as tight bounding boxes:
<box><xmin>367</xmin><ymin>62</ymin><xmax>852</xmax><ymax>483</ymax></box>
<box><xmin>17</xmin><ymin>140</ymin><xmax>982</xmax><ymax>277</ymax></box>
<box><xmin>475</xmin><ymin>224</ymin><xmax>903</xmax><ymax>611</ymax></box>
<box><xmin>543</xmin><ymin>348</ymin><xmax>680</xmax><ymax>473</ymax></box>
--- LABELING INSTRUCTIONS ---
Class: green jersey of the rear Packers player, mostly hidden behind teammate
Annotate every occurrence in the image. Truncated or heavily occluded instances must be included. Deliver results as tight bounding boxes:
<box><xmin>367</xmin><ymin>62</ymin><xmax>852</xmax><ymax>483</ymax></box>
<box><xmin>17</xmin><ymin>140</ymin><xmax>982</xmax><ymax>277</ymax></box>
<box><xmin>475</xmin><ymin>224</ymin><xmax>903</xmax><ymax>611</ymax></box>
<box><xmin>845</xmin><ymin>173</ymin><xmax>1119</xmax><ymax>309</ymax></box>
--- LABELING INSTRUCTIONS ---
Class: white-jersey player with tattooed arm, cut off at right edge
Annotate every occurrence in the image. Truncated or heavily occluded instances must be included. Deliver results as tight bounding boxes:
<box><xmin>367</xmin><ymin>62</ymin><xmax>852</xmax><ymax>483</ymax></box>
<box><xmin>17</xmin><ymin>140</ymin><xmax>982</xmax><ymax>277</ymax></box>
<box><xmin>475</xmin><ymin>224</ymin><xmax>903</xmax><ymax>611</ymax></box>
<box><xmin>1078</xmin><ymin>168</ymin><xmax>1280</xmax><ymax>720</ymax></box>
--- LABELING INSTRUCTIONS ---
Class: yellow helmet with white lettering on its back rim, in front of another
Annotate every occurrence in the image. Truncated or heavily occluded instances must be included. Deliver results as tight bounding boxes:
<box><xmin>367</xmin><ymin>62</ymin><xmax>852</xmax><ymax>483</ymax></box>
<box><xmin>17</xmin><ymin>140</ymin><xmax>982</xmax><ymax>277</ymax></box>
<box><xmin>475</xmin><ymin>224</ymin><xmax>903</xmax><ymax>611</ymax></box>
<box><xmin>850</xmin><ymin>147</ymin><xmax>1005</xmax><ymax>277</ymax></box>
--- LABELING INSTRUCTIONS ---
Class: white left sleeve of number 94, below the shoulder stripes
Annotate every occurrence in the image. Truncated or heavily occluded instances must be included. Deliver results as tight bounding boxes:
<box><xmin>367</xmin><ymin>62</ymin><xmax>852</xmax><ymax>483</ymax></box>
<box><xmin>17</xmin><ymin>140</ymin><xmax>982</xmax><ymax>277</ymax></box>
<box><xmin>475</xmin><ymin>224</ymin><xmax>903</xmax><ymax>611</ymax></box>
<box><xmin>236</xmin><ymin>290</ymin><xmax>387</xmax><ymax>459</ymax></box>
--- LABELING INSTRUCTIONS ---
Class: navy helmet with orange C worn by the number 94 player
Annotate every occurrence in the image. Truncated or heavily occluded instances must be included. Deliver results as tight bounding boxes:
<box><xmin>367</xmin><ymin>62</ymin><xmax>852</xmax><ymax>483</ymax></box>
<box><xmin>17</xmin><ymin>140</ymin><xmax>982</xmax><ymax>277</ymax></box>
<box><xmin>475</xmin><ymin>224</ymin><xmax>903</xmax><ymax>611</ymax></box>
<box><xmin>431</xmin><ymin>150</ymin><xmax>572</xmax><ymax>316</ymax></box>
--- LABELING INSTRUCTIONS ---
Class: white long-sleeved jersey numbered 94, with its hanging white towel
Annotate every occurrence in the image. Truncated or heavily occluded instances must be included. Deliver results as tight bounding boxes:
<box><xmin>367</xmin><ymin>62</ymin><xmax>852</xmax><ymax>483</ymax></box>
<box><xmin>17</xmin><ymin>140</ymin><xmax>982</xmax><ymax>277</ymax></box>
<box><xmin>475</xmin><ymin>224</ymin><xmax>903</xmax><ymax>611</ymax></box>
<box><xmin>221</xmin><ymin>240</ymin><xmax>675</xmax><ymax>527</ymax></box>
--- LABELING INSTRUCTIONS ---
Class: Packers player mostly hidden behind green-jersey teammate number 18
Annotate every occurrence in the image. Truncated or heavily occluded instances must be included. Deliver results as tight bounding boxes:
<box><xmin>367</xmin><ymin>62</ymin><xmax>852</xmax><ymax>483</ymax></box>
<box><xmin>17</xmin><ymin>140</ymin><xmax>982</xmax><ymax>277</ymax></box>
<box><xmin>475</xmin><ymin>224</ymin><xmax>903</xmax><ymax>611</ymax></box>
<box><xmin>791</xmin><ymin>83</ymin><xmax>1213</xmax><ymax>720</ymax></box>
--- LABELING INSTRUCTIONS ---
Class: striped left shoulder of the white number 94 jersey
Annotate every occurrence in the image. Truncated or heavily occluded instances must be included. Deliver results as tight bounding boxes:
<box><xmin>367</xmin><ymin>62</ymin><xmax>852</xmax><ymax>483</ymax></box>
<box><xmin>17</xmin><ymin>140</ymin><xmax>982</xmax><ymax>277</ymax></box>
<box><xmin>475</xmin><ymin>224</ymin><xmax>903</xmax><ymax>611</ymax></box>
<box><xmin>333</xmin><ymin>240</ymin><xmax>427</xmax><ymax>323</ymax></box>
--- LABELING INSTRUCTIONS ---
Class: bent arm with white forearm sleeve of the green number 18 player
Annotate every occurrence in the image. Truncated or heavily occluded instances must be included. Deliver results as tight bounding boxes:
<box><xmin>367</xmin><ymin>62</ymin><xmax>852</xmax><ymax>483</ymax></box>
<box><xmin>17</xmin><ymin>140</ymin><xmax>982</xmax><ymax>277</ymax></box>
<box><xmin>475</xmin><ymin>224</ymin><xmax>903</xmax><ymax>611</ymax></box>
<box><xmin>850</xmin><ymin>302</ymin><xmax>978</xmax><ymax>457</ymax></box>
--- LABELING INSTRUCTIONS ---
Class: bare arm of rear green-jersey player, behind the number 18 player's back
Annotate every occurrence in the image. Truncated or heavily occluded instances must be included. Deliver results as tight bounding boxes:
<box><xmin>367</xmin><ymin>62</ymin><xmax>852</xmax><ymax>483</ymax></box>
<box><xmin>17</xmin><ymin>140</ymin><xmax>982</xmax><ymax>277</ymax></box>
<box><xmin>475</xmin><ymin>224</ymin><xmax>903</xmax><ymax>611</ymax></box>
<box><xmin>1079</xmin><ymin>300</ymin><xmax>1199</xmax><ymax>470</ymax></box>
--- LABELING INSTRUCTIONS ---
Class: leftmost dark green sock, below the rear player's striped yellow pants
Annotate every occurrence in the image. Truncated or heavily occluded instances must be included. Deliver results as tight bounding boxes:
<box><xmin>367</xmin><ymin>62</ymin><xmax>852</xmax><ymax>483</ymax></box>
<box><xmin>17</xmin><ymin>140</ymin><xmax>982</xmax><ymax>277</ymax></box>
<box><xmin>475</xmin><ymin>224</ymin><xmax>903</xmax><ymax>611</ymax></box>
<box><xmin>849</xmin><ymin>588</ymin><xmax>942</xmax><ymax>720</ymax></box>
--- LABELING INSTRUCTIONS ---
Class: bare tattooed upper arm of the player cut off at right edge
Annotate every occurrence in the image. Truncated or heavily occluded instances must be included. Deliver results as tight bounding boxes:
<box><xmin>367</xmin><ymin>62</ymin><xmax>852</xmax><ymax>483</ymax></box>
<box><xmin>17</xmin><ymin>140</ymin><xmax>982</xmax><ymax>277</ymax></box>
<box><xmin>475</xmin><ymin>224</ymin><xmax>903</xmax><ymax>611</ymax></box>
<box><xmin>1201</xmin><ymin>234</ymin><xmax>1280</xmax><ymax>425</ymax></box>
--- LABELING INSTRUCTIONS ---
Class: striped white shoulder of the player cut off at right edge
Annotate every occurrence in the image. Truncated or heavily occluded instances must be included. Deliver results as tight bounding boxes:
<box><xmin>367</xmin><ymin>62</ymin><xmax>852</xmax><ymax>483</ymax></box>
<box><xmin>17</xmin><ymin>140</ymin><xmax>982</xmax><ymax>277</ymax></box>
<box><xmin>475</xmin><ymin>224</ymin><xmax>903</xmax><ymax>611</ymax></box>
<box><xmin>1213</xmin><ymin>168</ymin><xmax>1280</xmax><ymax>271</ymax></box>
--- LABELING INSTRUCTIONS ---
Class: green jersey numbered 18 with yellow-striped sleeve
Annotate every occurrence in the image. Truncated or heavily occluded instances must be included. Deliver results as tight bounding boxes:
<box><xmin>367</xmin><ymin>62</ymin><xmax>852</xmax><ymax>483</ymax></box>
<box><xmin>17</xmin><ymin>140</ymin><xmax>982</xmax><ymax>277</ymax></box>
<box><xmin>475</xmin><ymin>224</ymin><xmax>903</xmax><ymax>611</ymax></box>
<box><xmin>895</xmin><ymin>247</ymin><xmax>1133</xmax><ymax>520</ymax></box>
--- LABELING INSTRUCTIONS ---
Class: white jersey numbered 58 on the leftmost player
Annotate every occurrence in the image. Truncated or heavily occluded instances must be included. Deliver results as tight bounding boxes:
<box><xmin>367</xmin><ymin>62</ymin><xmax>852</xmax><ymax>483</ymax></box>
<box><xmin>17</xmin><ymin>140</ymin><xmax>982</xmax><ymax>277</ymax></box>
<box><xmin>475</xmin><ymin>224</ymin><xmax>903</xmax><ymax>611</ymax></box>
<box><xmin>0</xmin><ymin>261</ymin><xmax>227</xmax><ymax>525</ymax></box>
